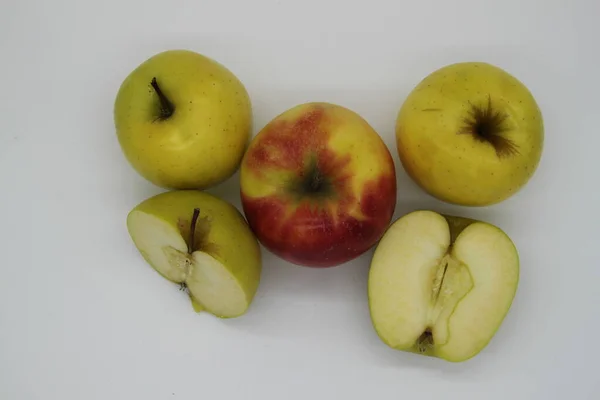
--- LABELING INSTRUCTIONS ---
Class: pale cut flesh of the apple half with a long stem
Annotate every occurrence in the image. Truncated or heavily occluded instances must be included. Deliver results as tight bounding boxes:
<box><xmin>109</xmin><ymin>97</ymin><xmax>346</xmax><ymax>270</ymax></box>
<box><xmin>128</xmin><ymin>211</ymin><xmax>248</xmax><ymax>318</ymax></box>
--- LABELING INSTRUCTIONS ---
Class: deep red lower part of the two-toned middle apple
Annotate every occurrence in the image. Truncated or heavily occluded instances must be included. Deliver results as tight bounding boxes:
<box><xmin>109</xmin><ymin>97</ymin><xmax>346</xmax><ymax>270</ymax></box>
<box><xmin>242</xmin><ymin>175</ymin><xmax>396</xmax><ymax>267</ymax></box>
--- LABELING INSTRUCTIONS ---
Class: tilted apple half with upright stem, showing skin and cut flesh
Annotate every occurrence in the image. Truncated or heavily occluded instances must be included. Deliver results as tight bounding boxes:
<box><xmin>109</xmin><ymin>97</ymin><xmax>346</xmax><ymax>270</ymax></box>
<box><xmin>127</xmin><ymin>190</ymin><xmax>262</xmax><ymax>318</ymax></box>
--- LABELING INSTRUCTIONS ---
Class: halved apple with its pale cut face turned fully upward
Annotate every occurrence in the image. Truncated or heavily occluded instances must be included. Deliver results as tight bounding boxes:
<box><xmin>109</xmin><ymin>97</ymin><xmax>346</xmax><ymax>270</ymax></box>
<box><xmin>368</xmin><ymin>211</ymin><xmax>519</xmax><ymax>362</ymax></box>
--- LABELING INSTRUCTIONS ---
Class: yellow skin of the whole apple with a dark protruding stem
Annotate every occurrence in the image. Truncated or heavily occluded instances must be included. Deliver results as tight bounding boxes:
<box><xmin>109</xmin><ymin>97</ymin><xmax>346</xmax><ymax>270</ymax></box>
<box><xmin>114</xmin><ymin>50</ymin><xmax>252</xmax><ymax>189</ymax></box>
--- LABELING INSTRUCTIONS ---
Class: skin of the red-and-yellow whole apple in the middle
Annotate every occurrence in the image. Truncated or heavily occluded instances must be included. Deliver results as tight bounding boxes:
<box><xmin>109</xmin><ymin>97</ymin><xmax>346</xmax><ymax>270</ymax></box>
<box><xmin>240</xmin><ymin>102</ymin><xmax>396</xmax><ymax>267</ymax></box>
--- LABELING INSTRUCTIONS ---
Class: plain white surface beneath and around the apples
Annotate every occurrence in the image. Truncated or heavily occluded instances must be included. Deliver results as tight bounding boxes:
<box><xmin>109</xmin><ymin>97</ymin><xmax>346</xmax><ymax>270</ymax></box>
<box><xmin>0</xmin><ymin>0</ymin><xmax>600</xmax><ymax>400</ymax></box>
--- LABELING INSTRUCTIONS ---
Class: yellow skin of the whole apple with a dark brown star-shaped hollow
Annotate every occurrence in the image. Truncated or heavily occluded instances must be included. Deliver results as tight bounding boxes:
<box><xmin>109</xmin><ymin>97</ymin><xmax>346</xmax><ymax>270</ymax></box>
<box><xmin>396</xmin><ymin>62</ymin><xmax>544</xmax><ymax>206</ymax></box>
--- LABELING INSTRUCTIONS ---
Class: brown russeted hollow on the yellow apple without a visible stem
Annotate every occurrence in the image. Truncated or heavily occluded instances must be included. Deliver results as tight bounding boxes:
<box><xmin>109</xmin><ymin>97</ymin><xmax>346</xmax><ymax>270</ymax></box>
<box><xmin>459</xmin><ymin>95</ymin><xmax>519</xmax><ymax>158</ymax></box>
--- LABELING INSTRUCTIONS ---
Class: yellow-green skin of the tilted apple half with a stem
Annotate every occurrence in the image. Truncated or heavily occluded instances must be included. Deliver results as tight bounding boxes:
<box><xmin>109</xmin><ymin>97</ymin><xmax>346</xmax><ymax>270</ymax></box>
<box><xmin>127</xmin><ymin>190</ymin><xmax>262</xmax><ymax>312</ymax></box>
